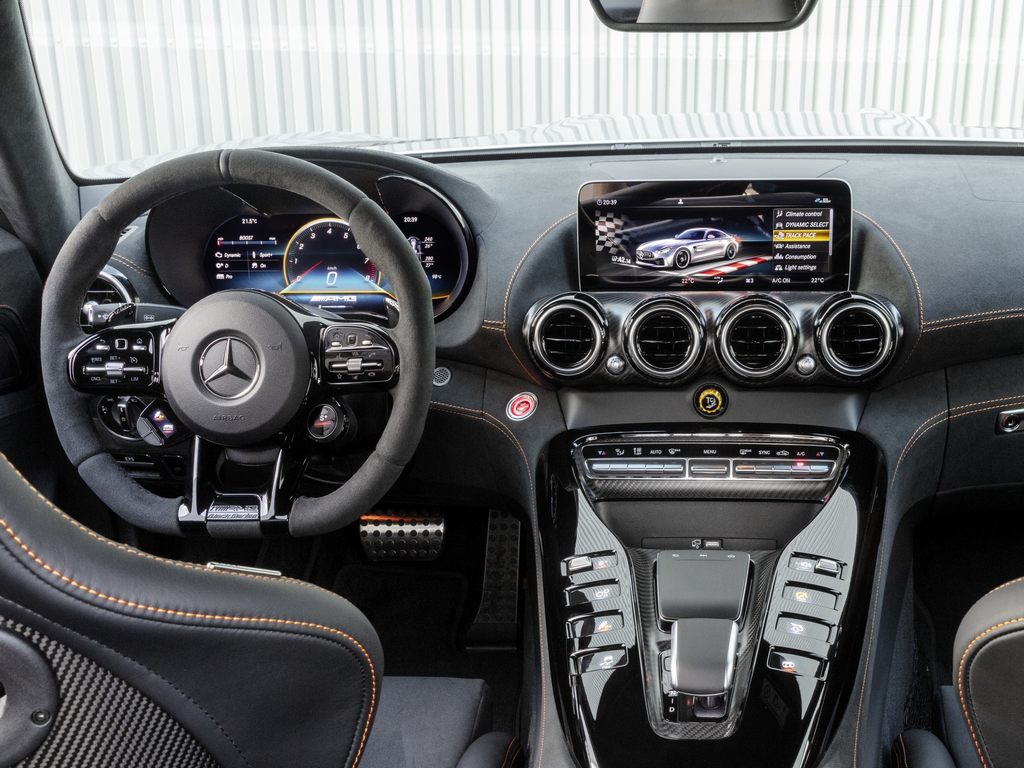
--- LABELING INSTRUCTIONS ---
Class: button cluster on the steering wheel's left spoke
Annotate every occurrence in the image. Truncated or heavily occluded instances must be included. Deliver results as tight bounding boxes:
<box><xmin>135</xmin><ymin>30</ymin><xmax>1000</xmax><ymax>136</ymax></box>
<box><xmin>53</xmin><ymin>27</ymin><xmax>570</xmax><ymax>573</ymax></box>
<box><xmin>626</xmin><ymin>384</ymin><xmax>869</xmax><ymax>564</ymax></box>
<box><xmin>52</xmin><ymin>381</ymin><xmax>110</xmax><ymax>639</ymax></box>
<box><xmin>70</xmin><ymin>329</ymin><xmax>156</xmax><ymax>390</ymax></box>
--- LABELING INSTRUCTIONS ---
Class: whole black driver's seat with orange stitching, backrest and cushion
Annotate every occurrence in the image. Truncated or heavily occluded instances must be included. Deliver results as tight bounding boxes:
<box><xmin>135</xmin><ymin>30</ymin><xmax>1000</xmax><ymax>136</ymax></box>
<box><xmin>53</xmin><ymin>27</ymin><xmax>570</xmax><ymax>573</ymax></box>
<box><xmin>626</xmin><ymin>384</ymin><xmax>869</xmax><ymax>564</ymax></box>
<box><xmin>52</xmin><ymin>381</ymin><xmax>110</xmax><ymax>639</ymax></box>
<box><xmin>0</xmin><ymin>457</ymin><xmax>521</xmax><ymax>768</ymax></box>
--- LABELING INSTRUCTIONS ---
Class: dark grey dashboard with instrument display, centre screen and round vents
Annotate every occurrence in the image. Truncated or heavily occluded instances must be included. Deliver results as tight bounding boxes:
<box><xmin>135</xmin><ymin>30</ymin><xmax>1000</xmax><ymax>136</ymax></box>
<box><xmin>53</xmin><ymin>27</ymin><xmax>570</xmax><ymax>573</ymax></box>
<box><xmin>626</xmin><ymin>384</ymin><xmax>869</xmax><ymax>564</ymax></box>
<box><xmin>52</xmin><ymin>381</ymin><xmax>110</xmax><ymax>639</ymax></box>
<box><xmin>101</xmin><ymin>147</ymin><xmax>1024</xmax><ymax>409</ymax></box>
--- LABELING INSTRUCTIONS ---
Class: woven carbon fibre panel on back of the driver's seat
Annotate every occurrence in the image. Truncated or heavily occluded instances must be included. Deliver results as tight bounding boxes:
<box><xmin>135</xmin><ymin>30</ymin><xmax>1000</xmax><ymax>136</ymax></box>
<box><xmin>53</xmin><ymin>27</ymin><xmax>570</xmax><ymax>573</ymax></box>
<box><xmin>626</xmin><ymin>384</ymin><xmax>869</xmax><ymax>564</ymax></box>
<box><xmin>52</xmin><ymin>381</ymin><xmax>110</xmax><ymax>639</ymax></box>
<box><xmin>0</xmin><ymin>616</ymin><xmax>217</xmax><ymax>768</ymax></box>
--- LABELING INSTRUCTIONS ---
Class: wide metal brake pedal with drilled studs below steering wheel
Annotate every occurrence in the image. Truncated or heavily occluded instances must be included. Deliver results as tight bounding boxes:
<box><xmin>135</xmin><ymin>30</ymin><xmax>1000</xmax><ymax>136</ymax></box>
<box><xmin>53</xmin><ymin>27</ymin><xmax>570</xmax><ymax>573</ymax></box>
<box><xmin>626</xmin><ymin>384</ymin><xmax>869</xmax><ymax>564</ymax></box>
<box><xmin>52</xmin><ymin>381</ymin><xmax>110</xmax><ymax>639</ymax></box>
<box><xmin>359</xmin><ymin>509</ymin><xmax>444</xmax><ymax>562</ymax></box>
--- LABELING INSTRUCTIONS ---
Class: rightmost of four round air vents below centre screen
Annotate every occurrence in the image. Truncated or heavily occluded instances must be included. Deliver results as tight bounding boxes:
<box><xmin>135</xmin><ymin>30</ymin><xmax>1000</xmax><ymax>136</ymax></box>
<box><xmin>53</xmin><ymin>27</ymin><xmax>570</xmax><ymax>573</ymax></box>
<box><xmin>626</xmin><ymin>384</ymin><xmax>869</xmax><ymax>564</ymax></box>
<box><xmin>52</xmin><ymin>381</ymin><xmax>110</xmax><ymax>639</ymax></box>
<box><xmin>816</xmin><ymin>297</ymin><xmax>896</xmax><ymax>376</ymax></box>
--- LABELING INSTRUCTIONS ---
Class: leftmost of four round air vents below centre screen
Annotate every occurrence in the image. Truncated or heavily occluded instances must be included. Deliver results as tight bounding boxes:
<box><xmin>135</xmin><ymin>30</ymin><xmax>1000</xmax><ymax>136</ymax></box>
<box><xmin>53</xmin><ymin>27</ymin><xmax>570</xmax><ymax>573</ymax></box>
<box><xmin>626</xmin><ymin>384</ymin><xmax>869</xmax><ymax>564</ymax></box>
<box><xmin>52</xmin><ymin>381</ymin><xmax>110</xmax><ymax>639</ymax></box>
<box><xmin>528</xmin><ymin>295</ymin><xmax>607</xmax><ymax>376</ymax></box>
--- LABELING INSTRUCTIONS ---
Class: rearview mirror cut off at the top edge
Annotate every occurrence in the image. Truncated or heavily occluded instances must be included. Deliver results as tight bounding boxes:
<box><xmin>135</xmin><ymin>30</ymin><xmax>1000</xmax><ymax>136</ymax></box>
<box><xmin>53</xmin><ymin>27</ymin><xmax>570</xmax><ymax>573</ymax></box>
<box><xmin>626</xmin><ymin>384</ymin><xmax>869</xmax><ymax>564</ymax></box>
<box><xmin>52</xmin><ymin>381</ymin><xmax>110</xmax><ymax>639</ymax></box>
<box><xmin>591</xmin><ymin>0</ymin><xmax>817</xmax><ymax>32</ymax></box>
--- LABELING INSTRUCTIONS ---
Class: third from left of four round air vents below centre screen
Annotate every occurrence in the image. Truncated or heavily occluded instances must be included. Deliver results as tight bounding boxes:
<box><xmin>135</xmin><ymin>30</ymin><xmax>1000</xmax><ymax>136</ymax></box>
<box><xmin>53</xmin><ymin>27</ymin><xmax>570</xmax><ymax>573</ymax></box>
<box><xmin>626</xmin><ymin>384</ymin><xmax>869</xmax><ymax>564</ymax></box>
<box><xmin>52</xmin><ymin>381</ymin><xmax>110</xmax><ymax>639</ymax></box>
<box><xmin>718</xmin><ymin>299</ymin><xmax>797</xmax><ymax>379</ymax></box>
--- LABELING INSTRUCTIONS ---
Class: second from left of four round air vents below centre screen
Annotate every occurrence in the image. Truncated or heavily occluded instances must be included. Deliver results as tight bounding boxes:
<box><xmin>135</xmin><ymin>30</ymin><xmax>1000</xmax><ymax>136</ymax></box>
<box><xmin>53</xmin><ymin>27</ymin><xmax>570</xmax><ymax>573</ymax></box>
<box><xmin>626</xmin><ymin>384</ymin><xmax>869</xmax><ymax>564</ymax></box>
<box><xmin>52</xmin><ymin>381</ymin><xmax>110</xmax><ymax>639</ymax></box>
<box><xmin>626</xmin><ymin>299</ymin><xmax>705</xmax><ymax>379</ymax></box>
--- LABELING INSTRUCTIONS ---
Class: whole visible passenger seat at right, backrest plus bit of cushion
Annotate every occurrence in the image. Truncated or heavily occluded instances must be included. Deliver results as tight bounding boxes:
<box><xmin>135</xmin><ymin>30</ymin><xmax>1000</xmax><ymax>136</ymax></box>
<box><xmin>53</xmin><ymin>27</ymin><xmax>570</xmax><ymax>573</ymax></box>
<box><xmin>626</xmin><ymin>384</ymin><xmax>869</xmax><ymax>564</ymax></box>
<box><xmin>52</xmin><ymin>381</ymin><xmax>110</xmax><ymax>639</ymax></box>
<box><xmin>893</xmin><ymin>579</ymin><xmax>1024</xmax><ymax>768</ymax></box>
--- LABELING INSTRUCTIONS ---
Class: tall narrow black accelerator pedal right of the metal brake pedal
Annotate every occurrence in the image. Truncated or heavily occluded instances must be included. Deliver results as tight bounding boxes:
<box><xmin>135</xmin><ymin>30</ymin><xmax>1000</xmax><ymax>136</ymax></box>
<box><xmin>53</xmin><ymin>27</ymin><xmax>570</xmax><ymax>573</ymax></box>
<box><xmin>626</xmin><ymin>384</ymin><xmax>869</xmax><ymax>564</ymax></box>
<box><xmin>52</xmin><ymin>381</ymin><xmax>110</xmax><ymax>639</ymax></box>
<box><xmin>466</xmin><ymin>509</ymin><xmax>521</xmax><ymax>645</ymax></box>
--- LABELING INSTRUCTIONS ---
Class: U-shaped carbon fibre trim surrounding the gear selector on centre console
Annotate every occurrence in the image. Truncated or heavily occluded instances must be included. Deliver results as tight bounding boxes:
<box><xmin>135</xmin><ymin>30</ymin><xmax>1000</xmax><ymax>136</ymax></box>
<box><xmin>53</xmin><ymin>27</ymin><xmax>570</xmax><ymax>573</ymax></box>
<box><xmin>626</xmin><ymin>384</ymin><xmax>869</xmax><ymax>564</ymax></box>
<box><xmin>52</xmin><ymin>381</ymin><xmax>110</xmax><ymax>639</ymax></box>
<box><xmin>627</xmin><ymin>548</ymin><xmax>778</xmax><ymax>739</ymax></box>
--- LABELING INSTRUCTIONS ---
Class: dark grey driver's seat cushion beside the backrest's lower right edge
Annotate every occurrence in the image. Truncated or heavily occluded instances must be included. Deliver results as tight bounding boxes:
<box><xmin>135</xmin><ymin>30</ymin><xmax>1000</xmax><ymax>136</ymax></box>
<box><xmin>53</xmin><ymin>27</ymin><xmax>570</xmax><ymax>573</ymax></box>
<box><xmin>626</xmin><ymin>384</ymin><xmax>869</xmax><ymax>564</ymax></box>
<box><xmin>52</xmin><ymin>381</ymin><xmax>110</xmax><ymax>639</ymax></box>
<box><xmin>361</xmin><ymin>677</ymin><xmax>518</xmax><ymax>768</ymax></box>
